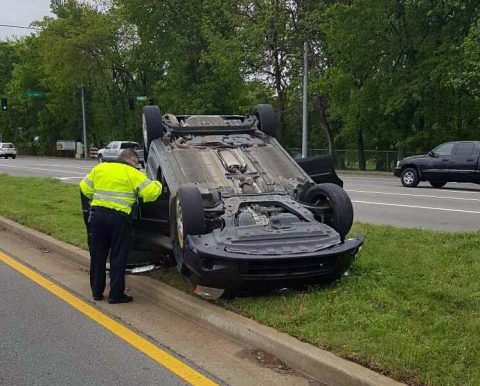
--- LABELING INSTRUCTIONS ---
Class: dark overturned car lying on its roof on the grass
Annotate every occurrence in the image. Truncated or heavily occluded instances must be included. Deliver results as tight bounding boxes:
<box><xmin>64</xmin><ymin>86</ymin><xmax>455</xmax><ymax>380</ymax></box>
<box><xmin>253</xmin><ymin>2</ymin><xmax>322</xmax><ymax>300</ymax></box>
<box><xmin>136</xmin><ymin>104</ymin><xmax>363</xmax><ymax>299</ymax></box>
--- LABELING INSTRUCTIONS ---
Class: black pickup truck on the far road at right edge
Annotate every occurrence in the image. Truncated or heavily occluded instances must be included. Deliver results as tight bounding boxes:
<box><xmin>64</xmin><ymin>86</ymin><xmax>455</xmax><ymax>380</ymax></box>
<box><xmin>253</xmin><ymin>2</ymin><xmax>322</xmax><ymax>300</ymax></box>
<box><xmin>393</xmin><ymin>141</ymin><xmax>480</xmax><ymax>188</ymax></box>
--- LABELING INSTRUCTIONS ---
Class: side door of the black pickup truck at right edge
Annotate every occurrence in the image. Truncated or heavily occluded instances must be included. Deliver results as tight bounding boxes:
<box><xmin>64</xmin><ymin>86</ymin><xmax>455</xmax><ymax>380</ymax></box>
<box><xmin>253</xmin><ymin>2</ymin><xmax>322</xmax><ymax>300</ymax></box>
<box><xmin>448</xmin><ymin>142</ymin><xmax>477</xmax><ymax>182</ymax></box>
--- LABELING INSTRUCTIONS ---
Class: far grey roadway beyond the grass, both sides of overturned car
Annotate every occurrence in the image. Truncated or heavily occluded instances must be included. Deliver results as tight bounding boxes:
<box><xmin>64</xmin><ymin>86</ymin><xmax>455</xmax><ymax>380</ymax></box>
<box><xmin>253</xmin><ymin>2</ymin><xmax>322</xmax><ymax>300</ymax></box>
<box><xmin>0</xmin><ymin>157</ymin><xmax>480</xmax><ymax>231</ymax></box>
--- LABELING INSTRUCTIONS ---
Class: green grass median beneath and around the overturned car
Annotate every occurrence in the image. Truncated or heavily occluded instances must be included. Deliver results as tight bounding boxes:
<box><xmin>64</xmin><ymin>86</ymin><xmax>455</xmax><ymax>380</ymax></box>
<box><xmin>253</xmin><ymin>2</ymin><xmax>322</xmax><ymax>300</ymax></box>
<box><xmin>0</xmin><ymin>175</ymin><xmax>480</xmax><ymax>385</ymax></box>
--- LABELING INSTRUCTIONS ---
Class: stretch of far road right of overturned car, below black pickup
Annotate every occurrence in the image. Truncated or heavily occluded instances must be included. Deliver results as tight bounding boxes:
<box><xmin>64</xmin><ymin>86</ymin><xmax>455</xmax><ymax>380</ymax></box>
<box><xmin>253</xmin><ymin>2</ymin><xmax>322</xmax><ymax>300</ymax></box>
<box><xmin>340</xmin><ymin>175</ymin><xmax>480</xmax><ymax>232</ymax></box>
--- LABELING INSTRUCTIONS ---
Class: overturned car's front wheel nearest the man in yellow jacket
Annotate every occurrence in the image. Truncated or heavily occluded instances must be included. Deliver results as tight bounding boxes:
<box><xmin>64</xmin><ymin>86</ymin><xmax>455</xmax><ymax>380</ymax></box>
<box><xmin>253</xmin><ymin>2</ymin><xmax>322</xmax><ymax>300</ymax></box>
<box><xmin>170</xmin><ymin>186</ymin><xmax>206</xmax><ymax>269</ymax></box>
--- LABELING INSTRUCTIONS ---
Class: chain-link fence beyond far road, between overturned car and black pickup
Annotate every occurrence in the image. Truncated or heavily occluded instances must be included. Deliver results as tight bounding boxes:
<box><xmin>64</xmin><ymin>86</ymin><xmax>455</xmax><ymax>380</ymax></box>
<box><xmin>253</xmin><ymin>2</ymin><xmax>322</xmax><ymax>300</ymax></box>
<box><xmin>287</xmin><ymin>148</ymin><xmax>414</xmax><ymax>172</ymax></box>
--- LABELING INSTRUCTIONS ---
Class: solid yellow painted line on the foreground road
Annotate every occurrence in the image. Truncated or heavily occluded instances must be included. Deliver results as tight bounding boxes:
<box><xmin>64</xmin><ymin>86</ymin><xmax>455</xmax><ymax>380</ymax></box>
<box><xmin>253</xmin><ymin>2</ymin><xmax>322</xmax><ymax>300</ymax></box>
<box><xmin>0</xmin><ymin>252</ymin><xmax>216</xmax><ymax>386</ymax></box>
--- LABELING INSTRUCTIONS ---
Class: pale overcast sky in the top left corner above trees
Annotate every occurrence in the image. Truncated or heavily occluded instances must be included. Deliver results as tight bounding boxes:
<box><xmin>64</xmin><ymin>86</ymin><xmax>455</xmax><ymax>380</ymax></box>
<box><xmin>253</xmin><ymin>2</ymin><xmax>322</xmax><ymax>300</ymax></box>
<box><xmin>0</xmin><ymin>0</ymin><xmax>52</xmax><ymax>40</ymax></box>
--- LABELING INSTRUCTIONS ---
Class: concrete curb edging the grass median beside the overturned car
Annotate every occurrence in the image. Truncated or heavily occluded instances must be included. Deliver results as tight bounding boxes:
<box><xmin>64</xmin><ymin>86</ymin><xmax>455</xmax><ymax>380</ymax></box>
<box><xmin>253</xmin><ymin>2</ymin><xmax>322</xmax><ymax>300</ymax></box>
<box><xmin>0</xmin><ymin>217</ymin><xmax>401</xmax><ymax>386</ymax></box>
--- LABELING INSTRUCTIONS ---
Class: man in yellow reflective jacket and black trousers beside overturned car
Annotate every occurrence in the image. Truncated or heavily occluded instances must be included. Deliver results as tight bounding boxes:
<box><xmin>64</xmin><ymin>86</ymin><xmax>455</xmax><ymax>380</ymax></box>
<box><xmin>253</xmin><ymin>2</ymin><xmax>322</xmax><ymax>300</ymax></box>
<box><xmin>80</xmin><ymin>149</ymin><xmax>162</xmax><ymax>304</ymax></box>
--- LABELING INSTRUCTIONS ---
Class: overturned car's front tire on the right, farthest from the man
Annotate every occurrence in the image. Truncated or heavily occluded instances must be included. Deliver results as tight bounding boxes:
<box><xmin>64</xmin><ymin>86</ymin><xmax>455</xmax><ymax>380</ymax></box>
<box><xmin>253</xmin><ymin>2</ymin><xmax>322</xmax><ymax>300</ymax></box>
<box><xmin>304</xmin><ymin>183</ymin><xmax>353</xmax><ymax>240</ymax></box>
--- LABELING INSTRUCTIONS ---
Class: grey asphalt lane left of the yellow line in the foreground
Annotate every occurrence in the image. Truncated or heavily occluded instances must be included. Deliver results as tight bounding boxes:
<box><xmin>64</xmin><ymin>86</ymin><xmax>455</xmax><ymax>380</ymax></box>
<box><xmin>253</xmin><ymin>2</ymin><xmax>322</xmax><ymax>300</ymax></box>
<box><xmin>0</xmin><ymin>262</ymin><xmax>187</xmax><ymax>385</ymax></box>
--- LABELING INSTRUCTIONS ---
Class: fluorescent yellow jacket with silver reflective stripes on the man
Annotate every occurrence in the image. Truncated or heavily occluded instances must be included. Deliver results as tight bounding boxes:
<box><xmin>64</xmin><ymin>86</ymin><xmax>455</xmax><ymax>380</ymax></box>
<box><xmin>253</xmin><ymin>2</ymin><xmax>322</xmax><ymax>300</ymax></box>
<box><xmin>80</xmin><ymin>162</ymin><xmax>162</xmax><ymax>214</ymax></box>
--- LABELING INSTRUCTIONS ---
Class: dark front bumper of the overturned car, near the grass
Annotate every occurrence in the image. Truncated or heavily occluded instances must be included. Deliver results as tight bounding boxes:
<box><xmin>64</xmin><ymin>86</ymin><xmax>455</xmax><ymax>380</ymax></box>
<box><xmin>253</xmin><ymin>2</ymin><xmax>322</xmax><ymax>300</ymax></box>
<box><xmin>184</xmin><ymin>237</ymin><xmax>364</xmax><ymax>290</ymax></box>
